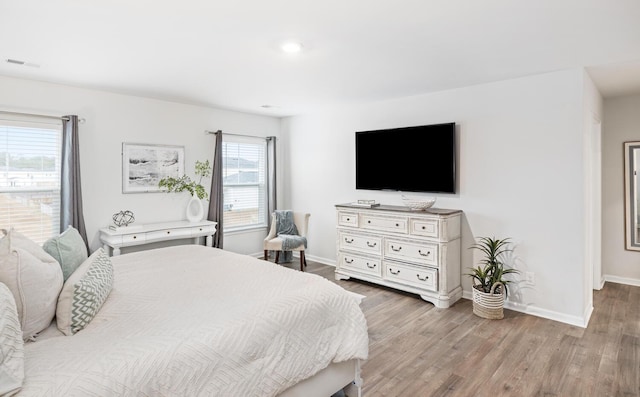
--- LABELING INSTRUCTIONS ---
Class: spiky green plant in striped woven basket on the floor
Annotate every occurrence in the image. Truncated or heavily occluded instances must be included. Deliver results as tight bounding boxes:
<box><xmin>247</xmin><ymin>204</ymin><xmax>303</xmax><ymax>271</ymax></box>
<box><xmin>467</xmin><ymin>237</ymin><xmax>518</xmax><ymax>320</ymax></box>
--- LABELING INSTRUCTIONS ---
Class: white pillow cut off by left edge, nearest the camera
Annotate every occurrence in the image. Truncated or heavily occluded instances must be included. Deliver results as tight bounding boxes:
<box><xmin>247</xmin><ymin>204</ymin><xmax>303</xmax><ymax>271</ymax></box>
<box><xmin>0</xmin><ymin>283</ymin><xmax>24</xmax><ymax>396</ymax></box>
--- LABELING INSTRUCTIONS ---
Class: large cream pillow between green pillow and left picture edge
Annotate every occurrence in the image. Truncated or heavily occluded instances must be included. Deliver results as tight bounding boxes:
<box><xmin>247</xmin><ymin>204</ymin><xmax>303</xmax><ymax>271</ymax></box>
<box><xmin>0</xmin><ymin>229</ymin><xmax>62</xmax><ymax>340</ymax></box>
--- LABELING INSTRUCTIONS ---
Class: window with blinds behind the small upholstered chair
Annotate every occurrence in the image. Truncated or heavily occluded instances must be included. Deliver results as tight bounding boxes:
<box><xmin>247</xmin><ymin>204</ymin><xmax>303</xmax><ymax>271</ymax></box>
<box><xmin>222</xmin><ymin>136</ymin><xmax>267</xmax><ymax>231</ymax></box>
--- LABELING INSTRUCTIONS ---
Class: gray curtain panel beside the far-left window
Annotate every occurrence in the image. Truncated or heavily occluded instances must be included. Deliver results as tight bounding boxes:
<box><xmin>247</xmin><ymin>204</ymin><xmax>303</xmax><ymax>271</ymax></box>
<box><xmin>60</xmin><ymin>115</ymin><xmax>89</xmax><ymax>249</ymax></box>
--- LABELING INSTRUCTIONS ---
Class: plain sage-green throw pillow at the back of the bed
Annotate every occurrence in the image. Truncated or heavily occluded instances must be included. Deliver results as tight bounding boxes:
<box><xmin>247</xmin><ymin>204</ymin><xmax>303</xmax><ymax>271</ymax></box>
<box><xmin>42</xmin><ymin>226</ymin><xmax>89</xmax><ymax>281</ymax></box>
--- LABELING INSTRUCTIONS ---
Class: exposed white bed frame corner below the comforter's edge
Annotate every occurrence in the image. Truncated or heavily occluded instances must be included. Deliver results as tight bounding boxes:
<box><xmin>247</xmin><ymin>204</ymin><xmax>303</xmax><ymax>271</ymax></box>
<box><xmin>279</xmin><ymin>360</ymin><xmax>362</xmax><ymax>397</ymax></box>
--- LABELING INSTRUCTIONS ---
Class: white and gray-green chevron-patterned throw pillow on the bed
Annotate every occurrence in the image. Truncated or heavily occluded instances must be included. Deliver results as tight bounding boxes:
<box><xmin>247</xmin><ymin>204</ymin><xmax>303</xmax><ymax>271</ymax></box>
<box><xmin>56</xmin><ymin>248</ymin><xmax>113</xmax><ymax>335</ymax></box>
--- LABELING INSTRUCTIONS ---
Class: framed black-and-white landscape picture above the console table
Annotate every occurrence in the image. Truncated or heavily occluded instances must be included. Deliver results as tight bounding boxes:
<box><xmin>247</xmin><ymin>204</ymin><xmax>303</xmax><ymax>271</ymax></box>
<box><xmin>122</xmin><ymin>142</ymin><xmax>184</xmax><ymax>193</ymax></box>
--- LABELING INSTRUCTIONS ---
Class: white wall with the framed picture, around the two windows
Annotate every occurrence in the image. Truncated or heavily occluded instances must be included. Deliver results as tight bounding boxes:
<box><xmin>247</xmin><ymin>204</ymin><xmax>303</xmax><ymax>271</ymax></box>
<box><xmin>0</xmin><ymin>77</ymin><xmax>280</xmax><ymax>253</ymax></box>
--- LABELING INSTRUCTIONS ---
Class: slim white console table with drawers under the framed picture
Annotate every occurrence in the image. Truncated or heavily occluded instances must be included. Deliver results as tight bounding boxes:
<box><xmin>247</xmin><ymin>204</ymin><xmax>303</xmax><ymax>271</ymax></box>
<box><xmin>100</xmin><ymin>221</ymin><xmax>217</xmax><ymax>256</ymax></box>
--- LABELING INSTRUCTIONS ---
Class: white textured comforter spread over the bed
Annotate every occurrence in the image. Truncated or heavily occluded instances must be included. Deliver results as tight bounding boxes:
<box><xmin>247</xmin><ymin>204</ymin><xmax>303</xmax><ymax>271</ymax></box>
<box><xmin>18</xmin><ymin>246</ymin><xmax>368</xmax><ymax>397</ymax></box>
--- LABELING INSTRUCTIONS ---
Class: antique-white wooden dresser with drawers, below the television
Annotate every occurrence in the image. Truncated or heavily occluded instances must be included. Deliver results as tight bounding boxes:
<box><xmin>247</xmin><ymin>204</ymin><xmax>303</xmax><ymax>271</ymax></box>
<box><xmin>335</xmin><ymin>204</ymin><xmax>462</xmax><ymax>308</ymax></box>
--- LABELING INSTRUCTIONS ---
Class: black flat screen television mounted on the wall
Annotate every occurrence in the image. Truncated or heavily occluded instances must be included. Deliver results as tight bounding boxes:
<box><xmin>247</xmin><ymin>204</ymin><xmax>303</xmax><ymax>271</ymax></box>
<box><xmin>356</xmin><ymin>123</ymin><xmax>456</xmax><ymax>193</ymax></box>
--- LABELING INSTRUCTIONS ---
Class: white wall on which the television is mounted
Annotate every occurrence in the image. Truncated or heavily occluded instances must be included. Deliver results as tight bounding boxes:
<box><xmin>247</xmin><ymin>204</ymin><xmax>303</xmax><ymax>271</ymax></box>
<box><xmin>281</xmin><ymin>70</ymin><xmax>586</xmax><ymax>325</ymax></box>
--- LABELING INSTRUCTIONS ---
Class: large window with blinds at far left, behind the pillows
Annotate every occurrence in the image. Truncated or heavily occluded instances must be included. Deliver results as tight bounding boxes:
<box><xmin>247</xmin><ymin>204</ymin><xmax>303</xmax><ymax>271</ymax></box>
<box><xmin>0</xmin><ymin>118</ymin><xmax>62</xmax><ymax>244</ymax></box>
